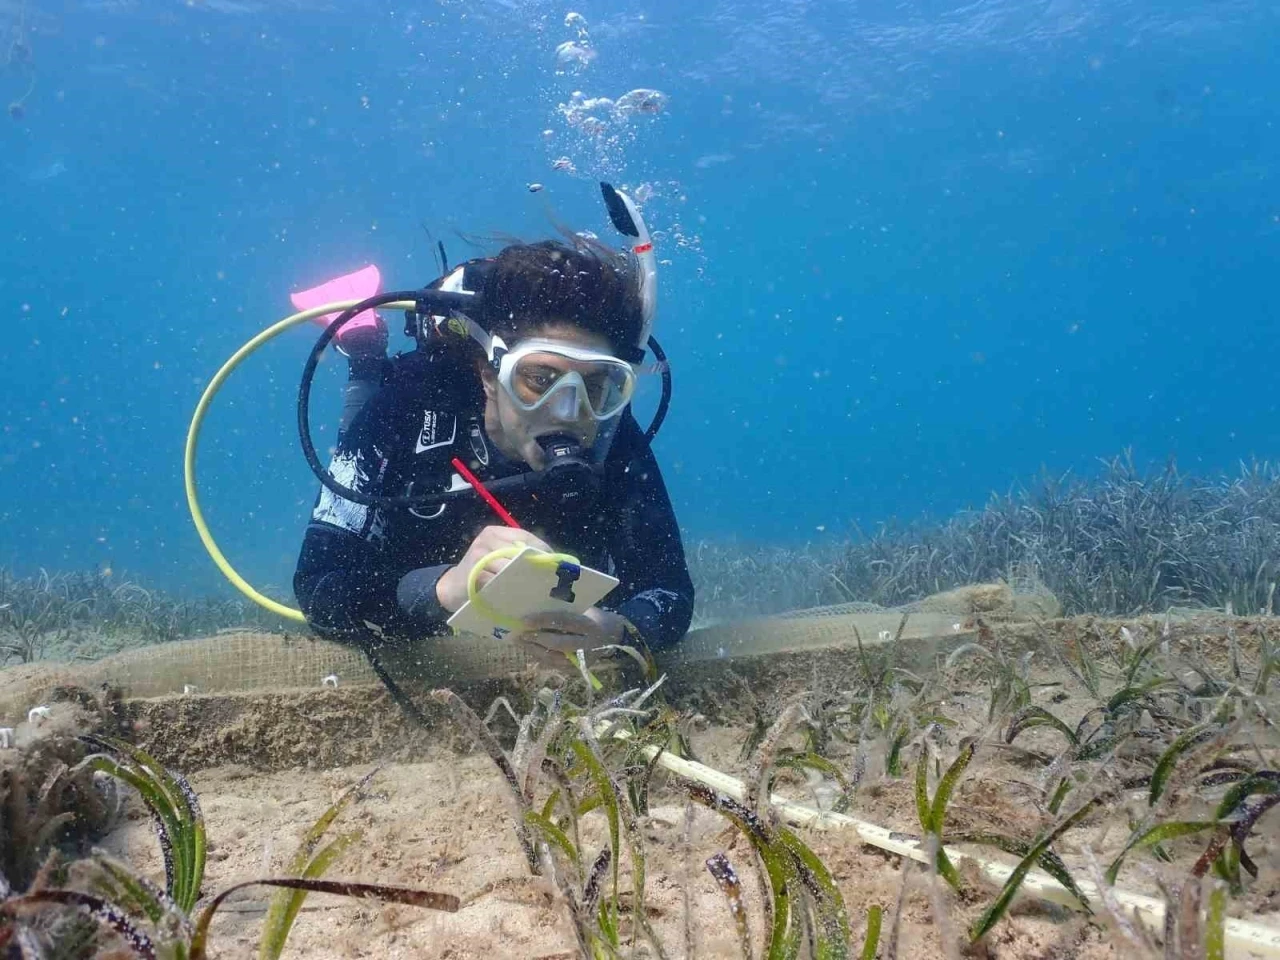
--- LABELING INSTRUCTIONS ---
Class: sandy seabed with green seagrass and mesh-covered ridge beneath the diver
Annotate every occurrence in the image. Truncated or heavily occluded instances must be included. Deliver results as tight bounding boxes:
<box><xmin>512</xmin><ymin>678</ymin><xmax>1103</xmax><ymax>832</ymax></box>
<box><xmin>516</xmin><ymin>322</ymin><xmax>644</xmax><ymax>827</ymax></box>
<box><xmin>0</xmin><ymin>463</ymin><xmax>1280</xmax><ymax>959</ymax></box>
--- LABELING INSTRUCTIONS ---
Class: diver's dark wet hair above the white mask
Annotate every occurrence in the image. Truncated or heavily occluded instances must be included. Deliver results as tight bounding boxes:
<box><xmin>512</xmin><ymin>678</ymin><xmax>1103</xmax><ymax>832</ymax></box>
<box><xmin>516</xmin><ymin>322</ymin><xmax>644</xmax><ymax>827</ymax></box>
<box><xmin>476</xmin><ymin>236</ymin><xmax>644</xmax><ymax>353</ymax></box>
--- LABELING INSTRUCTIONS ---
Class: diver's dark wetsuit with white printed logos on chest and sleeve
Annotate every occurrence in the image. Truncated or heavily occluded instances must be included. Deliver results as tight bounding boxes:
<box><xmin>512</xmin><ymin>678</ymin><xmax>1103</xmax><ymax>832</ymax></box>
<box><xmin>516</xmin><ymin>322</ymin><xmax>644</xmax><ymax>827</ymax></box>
<box><xmin>293</xmin><ymin>351</ymin><xmax>694</xmax><ymax>650</ymax></box>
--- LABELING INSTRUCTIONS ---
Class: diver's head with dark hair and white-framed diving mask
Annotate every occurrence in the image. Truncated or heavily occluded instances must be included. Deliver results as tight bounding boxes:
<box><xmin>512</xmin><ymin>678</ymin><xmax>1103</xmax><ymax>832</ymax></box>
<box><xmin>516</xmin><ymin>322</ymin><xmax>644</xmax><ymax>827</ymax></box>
<box><xmin>476</xmin><ymin>238</ymin><xmax>645</xmax><ymax>470</ymax></box>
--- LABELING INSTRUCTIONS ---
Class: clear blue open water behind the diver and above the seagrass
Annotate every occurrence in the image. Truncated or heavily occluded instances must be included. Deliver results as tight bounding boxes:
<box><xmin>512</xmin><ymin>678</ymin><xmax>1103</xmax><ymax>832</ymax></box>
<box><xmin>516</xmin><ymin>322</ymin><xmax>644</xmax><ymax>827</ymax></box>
<box><xmin>0</xmin><ymin>0</ymin><xmax>1280</xmax><ymax>593</ymax></box>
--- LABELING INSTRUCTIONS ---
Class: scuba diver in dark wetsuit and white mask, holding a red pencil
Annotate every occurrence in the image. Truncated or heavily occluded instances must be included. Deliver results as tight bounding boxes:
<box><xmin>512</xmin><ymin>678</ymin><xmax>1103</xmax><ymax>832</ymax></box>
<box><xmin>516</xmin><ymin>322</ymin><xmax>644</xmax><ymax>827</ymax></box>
<box><xmin>293</xmin><ymin>184</ymin><xmax>694</xmax><ymax>680</ymax></box>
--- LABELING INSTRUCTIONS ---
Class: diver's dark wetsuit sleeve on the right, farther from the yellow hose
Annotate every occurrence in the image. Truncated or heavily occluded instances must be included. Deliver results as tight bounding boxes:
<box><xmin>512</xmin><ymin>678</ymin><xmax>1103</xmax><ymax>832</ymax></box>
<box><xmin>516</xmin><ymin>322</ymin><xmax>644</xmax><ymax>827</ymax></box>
<box><xmin>602</xmin><ymin>419</ymin><xmax>694</xmax><ymax>650</ymax></box>
